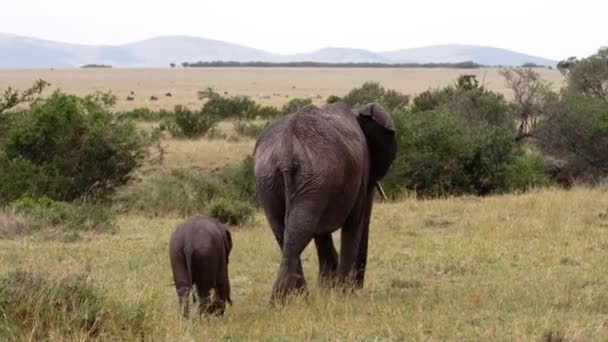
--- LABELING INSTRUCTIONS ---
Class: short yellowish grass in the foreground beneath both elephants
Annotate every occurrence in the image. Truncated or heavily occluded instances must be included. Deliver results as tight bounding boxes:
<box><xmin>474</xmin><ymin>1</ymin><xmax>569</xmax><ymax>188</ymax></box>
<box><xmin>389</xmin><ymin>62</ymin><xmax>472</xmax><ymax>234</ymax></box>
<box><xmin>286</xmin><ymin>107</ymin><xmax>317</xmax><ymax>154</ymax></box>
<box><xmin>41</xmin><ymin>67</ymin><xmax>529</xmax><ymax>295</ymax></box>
<box><xmin>0</xmin><ymin>133</ymin><xmax>608</xmax><ymax>341</ymax></box>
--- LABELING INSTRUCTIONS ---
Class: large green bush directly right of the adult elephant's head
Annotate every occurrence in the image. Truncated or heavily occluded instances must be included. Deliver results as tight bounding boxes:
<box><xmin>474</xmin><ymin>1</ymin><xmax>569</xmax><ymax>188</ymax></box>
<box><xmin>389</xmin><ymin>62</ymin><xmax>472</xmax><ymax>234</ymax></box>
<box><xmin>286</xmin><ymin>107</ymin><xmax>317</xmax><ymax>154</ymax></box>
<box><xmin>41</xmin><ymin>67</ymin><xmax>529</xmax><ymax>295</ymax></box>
<box><xmin>383</xmin><ymin>109</ymin><xmax>546</xmax><ymax>197</ymax></box>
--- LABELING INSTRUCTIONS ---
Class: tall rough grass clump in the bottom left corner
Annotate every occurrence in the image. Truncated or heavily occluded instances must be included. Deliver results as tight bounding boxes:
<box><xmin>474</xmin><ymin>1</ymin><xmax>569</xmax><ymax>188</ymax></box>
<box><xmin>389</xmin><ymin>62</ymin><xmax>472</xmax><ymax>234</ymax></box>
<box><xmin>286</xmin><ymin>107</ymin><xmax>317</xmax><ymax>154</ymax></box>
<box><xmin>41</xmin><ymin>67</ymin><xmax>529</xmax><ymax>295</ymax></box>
<box><xmin>0</xmin><ymin>270</ymin><xmax>153</xmax><ymax>341</ymax></box>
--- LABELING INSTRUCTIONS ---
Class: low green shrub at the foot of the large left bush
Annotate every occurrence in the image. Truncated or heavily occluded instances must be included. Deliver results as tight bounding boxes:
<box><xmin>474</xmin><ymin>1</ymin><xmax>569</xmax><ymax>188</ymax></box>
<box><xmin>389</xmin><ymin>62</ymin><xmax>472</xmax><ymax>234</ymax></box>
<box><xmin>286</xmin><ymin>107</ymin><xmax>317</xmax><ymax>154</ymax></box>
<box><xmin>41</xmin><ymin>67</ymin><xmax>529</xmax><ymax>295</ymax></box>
<box><xmin>9</xmin><ymin>197</ymin><xmax>115</xmax><ymax>233</ymax></box>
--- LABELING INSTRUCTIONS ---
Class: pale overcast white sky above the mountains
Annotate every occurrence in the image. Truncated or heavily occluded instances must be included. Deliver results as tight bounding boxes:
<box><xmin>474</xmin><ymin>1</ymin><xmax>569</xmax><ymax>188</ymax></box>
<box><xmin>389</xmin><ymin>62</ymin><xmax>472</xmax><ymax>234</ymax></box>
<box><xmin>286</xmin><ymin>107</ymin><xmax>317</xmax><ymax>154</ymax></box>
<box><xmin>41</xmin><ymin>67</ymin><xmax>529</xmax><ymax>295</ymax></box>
<box><xmin>0</xmin><ymin>0</ymin><xmax>608</xmax><ymax>59</ymax></box>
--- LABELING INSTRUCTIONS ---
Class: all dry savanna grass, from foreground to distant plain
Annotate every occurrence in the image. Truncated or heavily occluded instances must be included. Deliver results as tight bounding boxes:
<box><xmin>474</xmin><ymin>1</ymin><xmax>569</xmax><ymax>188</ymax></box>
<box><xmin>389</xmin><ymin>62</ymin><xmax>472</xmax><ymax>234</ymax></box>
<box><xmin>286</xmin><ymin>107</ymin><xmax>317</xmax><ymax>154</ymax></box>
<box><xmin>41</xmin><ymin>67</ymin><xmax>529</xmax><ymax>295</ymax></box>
<box><xmin>0</xmin><ymin>68</ymin><xmax>608</xmax><ymax>341</ymax></box>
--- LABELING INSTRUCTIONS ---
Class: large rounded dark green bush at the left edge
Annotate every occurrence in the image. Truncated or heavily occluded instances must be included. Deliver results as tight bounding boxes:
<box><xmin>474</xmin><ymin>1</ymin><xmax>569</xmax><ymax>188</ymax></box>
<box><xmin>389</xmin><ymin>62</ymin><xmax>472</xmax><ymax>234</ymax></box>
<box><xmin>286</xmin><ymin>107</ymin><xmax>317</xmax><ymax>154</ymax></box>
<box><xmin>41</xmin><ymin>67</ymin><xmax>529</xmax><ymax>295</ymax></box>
<box><xmin>0</xmin><ymin>91</ymin><xmax>150</xmax><ymax>203</ymax></box>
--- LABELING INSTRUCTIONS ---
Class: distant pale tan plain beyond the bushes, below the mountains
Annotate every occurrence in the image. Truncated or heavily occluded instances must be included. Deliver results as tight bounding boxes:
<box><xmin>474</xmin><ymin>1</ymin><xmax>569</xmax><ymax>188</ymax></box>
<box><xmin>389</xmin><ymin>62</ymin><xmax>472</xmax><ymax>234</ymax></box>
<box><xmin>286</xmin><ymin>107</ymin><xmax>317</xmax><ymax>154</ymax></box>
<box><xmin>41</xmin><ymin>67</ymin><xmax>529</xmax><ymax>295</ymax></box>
<box><xmin>0</xmin><ymin>68</ymin><xmax>563</xmax><ymax>110</ymax></box>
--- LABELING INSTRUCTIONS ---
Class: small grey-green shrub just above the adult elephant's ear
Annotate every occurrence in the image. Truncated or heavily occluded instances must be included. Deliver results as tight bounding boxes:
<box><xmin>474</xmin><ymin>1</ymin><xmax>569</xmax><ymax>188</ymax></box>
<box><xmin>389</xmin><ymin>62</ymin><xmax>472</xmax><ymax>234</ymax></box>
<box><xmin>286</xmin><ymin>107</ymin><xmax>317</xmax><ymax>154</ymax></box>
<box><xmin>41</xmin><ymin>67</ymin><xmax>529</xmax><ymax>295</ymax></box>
<box><xmin>342</xmin><ymin>82</ymin><xmax>410</xmax><ymax>112</ymax></box>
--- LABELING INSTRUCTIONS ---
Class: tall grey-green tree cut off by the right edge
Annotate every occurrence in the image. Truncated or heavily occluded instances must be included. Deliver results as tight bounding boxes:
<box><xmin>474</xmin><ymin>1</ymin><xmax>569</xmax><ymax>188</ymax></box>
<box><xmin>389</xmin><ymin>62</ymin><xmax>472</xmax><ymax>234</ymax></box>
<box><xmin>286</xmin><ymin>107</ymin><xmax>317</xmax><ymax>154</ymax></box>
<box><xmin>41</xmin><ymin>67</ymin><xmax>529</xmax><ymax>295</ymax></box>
<box><xmin>539</xmin><ymin>48</ymin><xmax>608</xmax><ymax>181</ymax></box>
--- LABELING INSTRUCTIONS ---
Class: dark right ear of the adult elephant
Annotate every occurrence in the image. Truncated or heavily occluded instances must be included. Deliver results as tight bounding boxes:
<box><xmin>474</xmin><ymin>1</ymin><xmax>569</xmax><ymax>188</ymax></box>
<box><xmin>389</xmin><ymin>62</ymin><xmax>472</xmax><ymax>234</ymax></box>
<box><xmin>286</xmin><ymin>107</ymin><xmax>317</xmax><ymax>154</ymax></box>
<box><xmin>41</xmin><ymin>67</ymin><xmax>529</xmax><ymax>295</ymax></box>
<box><xmin>357</xmin><ymin>103</ymin><xmax>397</xmax><ymax>181</ymax></box>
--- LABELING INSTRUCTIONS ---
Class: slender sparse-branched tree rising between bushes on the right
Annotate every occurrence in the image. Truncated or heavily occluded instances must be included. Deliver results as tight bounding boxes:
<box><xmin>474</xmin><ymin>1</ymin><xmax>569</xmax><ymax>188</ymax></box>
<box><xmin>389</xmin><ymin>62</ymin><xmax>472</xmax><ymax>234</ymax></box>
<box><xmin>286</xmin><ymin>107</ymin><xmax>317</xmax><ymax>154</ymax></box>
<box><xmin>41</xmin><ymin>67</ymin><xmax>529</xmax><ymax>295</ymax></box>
<box><xmin>499</xmin><ymin>67</ymin><xmax>551</xmax><ymax>140</ymax></box>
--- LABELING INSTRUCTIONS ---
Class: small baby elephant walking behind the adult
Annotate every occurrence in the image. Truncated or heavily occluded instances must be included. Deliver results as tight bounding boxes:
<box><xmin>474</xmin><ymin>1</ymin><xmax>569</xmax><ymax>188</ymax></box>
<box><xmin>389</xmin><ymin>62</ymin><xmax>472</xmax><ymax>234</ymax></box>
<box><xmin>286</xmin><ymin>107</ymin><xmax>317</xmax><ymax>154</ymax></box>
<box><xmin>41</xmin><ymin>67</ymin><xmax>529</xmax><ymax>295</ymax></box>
<box><xmin>169</xmin><ymin>216</ymin><xmax>232</xmax><ymax>318</ymax></box>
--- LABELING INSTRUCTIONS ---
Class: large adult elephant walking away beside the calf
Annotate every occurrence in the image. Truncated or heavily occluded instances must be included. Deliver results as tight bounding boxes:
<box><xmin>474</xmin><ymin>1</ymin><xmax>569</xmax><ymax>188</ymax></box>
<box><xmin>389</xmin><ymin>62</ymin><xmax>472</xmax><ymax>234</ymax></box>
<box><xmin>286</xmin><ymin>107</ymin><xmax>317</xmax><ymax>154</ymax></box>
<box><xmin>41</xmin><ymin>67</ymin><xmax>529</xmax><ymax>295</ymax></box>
<box><xmin>254</xmin><ymin>104</ymin><xmax>397</xmax><ymax>302</ymax></box>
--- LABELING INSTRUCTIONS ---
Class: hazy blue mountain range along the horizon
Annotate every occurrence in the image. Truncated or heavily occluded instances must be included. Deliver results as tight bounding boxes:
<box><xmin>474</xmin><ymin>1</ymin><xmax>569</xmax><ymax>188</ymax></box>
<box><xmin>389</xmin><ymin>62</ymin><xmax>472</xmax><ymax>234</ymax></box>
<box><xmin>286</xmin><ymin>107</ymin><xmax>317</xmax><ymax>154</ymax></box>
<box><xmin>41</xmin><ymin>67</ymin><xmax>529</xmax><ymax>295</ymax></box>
<box><xmin>0</xmin><ymin>33</ymin><xmax>556</xmax><ymax>68</ymax></box>
